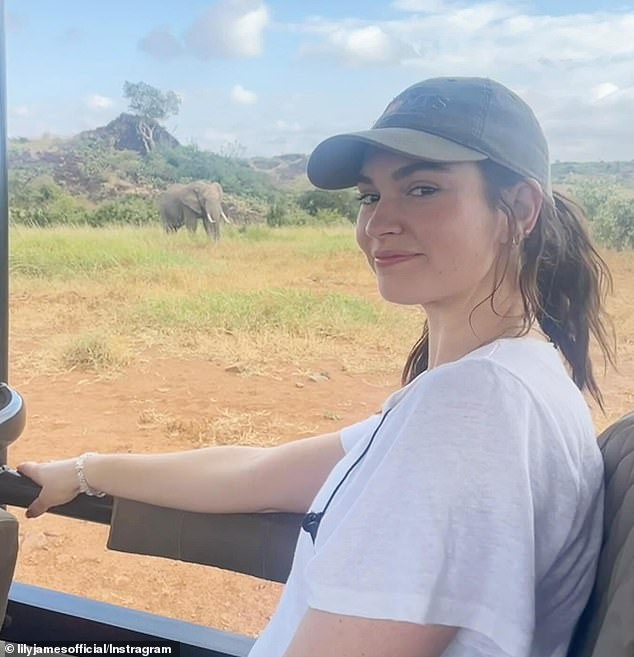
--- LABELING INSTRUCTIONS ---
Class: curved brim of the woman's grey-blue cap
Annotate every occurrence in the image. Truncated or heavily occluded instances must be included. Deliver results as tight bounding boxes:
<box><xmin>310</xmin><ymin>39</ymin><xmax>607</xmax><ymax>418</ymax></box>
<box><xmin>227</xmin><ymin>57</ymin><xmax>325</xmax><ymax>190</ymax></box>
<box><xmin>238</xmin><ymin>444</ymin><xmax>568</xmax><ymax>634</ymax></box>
<box><xmin>306</xmin><ymin>128</ymin><xmax>487</xmax><ymax>189</ymax></box>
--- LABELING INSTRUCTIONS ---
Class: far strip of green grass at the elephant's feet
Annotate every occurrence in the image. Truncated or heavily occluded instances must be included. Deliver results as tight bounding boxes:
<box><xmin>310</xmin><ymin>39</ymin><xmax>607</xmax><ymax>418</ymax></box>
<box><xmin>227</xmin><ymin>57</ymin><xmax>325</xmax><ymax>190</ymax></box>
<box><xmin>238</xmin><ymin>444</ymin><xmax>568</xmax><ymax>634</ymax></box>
<box><xmin>10</xmin><ymin>226</ymin><xmax>356</xmax><ymax>279</ymax></box>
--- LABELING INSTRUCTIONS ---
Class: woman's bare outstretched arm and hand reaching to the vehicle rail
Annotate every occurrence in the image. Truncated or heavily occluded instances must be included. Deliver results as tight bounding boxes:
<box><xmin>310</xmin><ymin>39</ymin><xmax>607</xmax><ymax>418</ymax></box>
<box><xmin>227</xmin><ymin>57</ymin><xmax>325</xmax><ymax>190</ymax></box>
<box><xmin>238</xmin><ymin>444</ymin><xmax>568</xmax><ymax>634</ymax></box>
<box><xmin>18</xmin><ymin>433</ymin><xmax>344</xmax><ymax>517</ymax></box>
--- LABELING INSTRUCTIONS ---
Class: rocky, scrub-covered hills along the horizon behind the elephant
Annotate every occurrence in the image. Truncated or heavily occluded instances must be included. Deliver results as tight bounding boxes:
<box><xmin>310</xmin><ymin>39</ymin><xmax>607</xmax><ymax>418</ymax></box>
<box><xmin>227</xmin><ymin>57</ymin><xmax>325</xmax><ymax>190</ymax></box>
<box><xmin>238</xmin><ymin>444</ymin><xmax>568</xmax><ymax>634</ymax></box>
<box><xmin>9</xmin><ymin>113</ymin><xmax>634</xmax><ymax>202</ymax></box>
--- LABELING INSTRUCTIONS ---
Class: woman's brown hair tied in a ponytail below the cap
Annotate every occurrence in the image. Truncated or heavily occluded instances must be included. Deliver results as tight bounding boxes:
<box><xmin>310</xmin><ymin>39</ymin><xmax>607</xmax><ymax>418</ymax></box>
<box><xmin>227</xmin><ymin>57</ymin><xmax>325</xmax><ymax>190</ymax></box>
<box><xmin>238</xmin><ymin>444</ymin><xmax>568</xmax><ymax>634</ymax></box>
<box><xmin>401</xmin><ymin>160</ymin><xmax>616</xmax><ymax>410</ymax></box>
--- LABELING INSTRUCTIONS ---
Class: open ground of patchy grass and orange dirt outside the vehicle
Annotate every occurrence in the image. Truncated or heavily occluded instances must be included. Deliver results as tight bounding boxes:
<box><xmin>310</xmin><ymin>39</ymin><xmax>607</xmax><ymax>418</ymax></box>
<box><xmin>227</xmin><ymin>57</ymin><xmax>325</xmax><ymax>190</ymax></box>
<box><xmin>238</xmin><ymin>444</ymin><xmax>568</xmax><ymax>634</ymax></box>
<box><xmin>10</xmin><ymin>226</ymin><xmax>634</xmax><ymax>636</ymax></box>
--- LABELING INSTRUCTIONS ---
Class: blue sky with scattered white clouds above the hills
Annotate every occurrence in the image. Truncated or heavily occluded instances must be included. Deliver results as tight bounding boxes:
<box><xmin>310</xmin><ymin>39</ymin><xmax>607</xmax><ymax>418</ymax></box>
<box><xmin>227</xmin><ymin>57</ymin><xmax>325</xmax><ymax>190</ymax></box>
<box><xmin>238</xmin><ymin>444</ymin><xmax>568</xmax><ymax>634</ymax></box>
<box><xmin>5</xmin><ymin>0</ymin><xmax>634</xmax><ymax>161</ymax></box>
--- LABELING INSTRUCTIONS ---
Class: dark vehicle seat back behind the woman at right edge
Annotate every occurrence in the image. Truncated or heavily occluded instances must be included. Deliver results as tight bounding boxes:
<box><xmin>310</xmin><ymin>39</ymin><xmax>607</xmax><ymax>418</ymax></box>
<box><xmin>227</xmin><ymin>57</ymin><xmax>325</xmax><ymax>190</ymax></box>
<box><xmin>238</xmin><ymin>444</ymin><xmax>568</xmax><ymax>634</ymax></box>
<box><xmin>568</xmin><ymin>413</ymin><xmax>634</xmax><ymax>657</ymax></box>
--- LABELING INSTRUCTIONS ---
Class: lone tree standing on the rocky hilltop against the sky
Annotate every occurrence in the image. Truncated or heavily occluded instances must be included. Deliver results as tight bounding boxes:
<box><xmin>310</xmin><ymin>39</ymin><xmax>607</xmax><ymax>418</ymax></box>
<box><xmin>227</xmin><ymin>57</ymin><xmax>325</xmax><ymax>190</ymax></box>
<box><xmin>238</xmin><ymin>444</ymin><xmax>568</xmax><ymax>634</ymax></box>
<box><xmin>123</xmin><ymin>80</ymin><xmax>181</xmax><ymax>155</ymax></box>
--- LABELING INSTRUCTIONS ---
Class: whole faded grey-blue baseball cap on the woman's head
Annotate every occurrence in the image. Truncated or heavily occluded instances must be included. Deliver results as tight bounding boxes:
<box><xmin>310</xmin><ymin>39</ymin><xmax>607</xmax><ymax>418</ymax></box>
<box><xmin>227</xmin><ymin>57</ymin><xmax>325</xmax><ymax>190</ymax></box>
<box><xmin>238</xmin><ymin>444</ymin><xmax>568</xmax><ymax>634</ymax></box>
<box><xmin>307</xmin><ymin>77</ymin><xmax>551</xmax><ymax>193</ymax></box>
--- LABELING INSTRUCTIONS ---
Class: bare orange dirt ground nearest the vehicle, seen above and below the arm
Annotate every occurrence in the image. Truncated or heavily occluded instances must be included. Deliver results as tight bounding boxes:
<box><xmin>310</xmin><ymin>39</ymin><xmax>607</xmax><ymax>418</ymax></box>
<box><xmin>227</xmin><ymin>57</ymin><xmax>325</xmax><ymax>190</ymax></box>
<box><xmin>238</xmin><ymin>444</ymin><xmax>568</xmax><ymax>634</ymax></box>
<box><xmin>9</xmin><ymin>352</ymin><xmax>398</xmax><ymax>636</ymax></box>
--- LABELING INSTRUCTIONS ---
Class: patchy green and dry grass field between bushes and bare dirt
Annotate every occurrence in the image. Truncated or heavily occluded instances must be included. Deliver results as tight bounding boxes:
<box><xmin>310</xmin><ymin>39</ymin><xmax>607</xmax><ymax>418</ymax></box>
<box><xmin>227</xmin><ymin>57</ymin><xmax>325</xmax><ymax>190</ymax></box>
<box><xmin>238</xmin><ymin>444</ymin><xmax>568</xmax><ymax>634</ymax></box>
<box><xmin>10</xmin><ymin>226</ymin><xmax>420</xmax><ymax>380</ymax></box>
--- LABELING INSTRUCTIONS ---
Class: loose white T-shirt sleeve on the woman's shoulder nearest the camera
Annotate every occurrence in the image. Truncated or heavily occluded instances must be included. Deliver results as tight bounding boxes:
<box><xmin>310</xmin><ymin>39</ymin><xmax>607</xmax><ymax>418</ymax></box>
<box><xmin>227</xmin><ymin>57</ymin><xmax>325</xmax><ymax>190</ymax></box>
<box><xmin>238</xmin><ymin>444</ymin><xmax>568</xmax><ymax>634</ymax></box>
<box><xmin>305</xmin><ymin>359</ymin><xmax>535</xmax><ymax>657</ymax></box>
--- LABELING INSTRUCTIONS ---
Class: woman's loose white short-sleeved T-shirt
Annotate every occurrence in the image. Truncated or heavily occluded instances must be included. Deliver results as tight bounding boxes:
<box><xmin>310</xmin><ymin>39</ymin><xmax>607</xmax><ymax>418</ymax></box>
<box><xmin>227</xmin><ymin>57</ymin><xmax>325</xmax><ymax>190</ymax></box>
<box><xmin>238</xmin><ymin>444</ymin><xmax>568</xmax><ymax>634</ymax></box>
<box><xmin>244</xmin><ymin>338</ymin><xmax>603</xmax><ymax>657</ymax></box>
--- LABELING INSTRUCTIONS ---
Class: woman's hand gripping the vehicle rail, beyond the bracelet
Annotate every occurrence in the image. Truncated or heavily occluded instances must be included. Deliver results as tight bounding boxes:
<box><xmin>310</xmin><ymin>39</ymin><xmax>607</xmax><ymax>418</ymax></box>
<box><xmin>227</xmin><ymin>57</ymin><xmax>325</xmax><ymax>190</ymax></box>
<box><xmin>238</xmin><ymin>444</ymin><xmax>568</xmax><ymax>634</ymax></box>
<box><xmin>17</xmin><ymin>459</ymin><xmax>79</xmax><ymax>518</ymax></box>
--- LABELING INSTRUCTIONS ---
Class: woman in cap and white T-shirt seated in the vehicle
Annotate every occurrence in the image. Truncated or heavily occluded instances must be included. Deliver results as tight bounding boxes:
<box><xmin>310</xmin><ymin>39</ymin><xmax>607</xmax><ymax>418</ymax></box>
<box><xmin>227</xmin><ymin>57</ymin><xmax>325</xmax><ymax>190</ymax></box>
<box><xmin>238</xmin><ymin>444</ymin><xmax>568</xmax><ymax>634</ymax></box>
<box><xmin>20</xmin><ymin>78</ymin><xmax>612</xmax><ymax>657</ymax></box>
